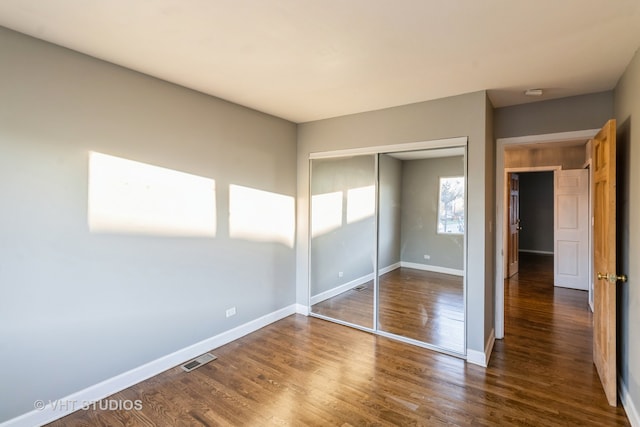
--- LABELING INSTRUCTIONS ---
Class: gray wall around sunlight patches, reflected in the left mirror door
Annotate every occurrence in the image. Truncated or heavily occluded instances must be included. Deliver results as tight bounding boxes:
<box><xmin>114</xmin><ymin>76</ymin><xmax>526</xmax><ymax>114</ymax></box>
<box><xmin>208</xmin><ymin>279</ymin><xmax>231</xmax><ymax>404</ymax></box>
<box><xmin>311</xmin><ymin>155</ymin><xmax>376</xmax><ymax>296</ymax></box>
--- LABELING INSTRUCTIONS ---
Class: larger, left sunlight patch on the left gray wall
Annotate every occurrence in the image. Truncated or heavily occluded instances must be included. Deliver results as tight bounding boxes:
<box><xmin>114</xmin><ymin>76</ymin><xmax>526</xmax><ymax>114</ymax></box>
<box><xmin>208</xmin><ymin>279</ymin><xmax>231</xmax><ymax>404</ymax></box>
<box><xmin>88</xmin><ymin>151</ymin><xmax>216</xmax><ymax>237</ymax></box>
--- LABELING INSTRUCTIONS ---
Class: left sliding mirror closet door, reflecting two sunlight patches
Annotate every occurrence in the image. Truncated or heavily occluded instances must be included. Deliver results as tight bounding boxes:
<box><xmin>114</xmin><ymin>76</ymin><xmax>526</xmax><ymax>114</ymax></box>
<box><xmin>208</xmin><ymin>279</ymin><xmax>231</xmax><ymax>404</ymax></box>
<box><xmin>310</xmin><ymin>155</ymin><xmax>376</xmax><ymax>329</ymax></box>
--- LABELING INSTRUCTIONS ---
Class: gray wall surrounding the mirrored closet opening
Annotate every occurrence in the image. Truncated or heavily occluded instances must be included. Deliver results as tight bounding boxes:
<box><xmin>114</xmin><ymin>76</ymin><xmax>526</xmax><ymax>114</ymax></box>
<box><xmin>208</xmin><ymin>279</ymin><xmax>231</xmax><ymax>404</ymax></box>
<box><xmin>296</xmin><ymin>91</ymin><xmax>495</xmax><ymax>353</ymax></box>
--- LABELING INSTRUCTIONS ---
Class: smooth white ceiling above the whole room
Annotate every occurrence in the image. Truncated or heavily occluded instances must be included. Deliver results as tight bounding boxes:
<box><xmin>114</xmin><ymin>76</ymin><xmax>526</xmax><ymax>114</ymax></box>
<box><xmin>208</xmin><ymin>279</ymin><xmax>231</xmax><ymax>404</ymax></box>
<box><xmin>0</xmin><ymin>0</ymin><xmax>640</xmax><ymax>123</ymax></box>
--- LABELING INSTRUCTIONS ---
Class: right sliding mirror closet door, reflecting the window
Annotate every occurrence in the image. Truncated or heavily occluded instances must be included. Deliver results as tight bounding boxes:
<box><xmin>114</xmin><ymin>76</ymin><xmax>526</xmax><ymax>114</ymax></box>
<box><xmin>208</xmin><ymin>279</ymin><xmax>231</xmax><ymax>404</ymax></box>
<box><xmin>377</xmin><ymin>147</ymin><xmax>466</xmax><ymax>354</ymax></box>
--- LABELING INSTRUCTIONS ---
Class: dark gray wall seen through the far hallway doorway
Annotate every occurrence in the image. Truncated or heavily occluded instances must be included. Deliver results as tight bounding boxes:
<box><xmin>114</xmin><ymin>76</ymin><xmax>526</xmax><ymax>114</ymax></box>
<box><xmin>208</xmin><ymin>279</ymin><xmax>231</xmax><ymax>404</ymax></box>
<box><xmin>519</xmin><ymin>172</ymin><xmax>554</xmax><ymax>253</ymax></box>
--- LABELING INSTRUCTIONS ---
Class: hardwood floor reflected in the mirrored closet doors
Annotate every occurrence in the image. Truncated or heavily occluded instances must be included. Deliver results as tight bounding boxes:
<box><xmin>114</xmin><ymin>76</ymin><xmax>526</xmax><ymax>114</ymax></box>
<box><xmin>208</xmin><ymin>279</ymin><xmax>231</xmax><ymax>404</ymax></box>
<box><xmin>313</xmin><ymin>267</ymin><xmax>464</xmax><ymax>353</ymax></box>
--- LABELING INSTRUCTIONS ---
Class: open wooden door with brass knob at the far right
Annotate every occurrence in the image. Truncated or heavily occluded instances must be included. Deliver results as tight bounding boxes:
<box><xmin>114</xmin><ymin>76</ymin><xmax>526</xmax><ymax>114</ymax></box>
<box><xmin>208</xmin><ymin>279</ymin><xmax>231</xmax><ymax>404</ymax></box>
<box><xmin>591</xmin><ymin>120</ymin><xmax>626</xmax><ymax>406</ymax></box>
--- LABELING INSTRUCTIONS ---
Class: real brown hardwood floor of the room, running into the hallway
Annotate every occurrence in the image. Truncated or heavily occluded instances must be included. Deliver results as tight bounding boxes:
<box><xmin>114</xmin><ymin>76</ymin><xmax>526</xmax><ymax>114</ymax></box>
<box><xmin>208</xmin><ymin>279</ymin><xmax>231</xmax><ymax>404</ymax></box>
<box><xmin>51</xmin><ymin>257</ymin><xmax>629</xmax><ymax>426</ymax></box>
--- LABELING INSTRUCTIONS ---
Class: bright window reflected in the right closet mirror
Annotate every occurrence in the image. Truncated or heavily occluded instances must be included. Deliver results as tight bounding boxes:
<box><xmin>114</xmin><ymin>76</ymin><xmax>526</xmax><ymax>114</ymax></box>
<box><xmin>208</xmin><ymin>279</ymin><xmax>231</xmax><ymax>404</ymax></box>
<box><xmin>438</xmin><ymin>176</ymin><xmax>464</xmax><ymax>234</ymax></box>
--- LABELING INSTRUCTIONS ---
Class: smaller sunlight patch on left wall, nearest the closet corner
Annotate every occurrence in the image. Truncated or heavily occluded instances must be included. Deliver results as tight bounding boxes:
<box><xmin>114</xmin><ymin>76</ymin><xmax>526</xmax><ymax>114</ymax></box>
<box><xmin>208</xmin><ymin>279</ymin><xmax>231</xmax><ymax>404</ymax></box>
<box><xmin>229</xmin><ymin>184</ymin><xmax>295</xmax><ymax>248</ymax></box>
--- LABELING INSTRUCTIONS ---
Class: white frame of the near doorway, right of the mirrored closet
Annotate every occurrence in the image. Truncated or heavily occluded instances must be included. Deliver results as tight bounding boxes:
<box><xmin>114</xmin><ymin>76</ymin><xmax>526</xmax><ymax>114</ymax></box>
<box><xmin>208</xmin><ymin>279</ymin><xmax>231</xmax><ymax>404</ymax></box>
<box><xmin>494</xmin><ymin>129</ymin><xmax>600</xmax><ymax>339</ymax></box>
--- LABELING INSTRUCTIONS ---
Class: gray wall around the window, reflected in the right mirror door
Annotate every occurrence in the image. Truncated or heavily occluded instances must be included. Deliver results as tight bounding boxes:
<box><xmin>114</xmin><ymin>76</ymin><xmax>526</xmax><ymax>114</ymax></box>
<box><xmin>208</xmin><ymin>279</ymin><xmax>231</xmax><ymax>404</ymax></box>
<box><xmin>401</xmin><ymin>156</ymin><xmax>464</xmax><ymax>270</ymax></box>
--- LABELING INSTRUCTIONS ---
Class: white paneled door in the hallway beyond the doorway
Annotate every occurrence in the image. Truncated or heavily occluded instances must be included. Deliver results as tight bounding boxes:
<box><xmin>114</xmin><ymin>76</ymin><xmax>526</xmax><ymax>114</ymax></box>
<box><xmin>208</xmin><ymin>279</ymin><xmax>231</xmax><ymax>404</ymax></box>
<box><xmin>554</xmin><ymin>169</ymin><xmax>589</xmax><ymax>291</ymax></box>
